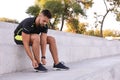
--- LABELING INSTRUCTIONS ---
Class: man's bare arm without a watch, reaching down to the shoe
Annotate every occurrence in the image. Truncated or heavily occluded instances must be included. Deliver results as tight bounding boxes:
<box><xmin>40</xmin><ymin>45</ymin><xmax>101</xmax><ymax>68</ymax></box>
<box><xmin>22</xmin><ymin>32</ymin><xmax>38</xmax><ymax>67</ymax></box>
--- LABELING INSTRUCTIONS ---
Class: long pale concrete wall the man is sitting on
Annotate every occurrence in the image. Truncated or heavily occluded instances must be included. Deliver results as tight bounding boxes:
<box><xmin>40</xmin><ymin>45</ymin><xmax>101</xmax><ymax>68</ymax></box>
<box><xmin>0</xmin><ymin>22</ymin><xmax>120</xmax><ymax>74</ymax></box>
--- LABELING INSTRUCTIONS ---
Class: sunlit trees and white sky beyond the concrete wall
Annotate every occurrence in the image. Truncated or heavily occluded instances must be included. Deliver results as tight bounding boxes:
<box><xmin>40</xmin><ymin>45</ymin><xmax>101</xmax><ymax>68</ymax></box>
<box><xmin>0</xmin><ymin>0</ymin><xmax>120</xmax><ymax>37</ymax></box>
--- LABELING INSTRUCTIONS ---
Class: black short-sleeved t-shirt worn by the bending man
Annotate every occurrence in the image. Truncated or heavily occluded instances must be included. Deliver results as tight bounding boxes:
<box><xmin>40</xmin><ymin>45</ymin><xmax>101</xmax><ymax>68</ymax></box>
<box><xmin>14</xmin><ymin>17</ymin><xmax>48</xmax><ymax>35</ymax></box>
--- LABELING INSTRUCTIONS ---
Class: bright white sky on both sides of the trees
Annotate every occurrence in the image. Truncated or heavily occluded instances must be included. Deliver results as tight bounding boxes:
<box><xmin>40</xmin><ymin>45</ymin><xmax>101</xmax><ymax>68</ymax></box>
<box><xmin>0</xmin><ymin>0</ymin><xmax>120</xmax><ymax>30</ymax></box>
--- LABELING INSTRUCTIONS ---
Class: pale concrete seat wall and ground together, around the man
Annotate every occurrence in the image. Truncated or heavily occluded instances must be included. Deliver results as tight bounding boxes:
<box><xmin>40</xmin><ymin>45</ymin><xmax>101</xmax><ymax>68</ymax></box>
<box><xmin>0</xmin><ymin>22</ymin><xmax>120</xmax><ymax>80</ymax></box>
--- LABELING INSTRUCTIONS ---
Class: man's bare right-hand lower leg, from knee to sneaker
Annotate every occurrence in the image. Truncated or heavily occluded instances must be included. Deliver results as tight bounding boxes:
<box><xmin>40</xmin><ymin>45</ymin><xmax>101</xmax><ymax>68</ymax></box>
<box><xmin>47</xmin><ymin>36</ymin><xmax>59</xmax><ymax>64</ymax></box>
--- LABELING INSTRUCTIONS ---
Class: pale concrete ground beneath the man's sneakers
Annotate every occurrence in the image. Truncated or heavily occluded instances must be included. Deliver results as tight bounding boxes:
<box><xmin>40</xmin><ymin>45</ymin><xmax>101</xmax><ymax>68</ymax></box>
<box><xmin>0</xmin><ymin>55</ymin><xmax>120</xmax><ymax>80</ymax></box>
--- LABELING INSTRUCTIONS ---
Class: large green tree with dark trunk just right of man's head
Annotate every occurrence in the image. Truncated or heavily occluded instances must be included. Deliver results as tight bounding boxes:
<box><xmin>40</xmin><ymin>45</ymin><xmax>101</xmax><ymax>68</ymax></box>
<box><xmin>44</xmin><ymin>0</ymin><xmax>84</xmax><ymax>31</ymax></box>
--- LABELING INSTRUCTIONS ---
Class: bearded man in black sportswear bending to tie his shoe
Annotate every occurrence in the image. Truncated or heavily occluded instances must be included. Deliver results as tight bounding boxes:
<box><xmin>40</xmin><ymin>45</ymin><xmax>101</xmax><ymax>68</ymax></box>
<box><xmin>14</xmin><ymin>10</ymin><xmax>69</xmax><ymax>71</ymax></box>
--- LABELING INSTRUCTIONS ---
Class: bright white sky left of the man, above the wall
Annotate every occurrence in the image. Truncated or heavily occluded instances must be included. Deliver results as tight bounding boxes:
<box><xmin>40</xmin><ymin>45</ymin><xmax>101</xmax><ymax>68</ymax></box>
<box><xmin>0</xmin><ymin>0</ymin><xmax>35</xmax><ymax>22</ymax></box>
